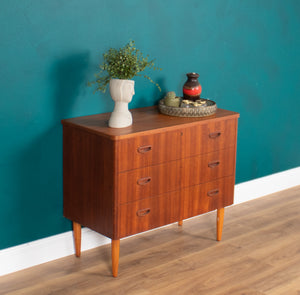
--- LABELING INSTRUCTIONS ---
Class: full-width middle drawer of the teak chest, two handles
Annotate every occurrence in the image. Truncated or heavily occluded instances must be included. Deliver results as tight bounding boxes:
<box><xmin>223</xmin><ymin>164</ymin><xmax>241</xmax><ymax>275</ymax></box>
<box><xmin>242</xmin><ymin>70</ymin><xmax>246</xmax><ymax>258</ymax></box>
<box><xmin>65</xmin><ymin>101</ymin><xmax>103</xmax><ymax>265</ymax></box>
<box><xmin>118</xmin><ymin>148</ymin><xmax>235</xmax><ymax>204</ymax></box>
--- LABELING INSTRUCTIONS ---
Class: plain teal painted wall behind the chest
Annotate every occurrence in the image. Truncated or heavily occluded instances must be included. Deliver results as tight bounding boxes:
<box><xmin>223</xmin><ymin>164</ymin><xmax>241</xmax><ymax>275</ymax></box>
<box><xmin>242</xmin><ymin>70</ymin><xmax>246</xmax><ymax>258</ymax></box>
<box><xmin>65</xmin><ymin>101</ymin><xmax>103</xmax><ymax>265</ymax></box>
<box><xmin>0</xmin><ymin>0</ymin><xmax>300</xmax><ymax>249</ymax></box>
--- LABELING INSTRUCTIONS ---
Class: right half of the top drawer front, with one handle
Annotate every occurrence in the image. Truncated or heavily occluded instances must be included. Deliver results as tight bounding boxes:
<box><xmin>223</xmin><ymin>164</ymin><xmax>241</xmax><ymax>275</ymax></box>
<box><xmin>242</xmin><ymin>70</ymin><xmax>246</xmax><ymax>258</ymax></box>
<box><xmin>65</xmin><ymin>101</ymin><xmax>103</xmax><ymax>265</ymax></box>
<box><xmin>182</xmin><ymin>119</ymin><xmax>237</xmax><ymax>158</ymax></box>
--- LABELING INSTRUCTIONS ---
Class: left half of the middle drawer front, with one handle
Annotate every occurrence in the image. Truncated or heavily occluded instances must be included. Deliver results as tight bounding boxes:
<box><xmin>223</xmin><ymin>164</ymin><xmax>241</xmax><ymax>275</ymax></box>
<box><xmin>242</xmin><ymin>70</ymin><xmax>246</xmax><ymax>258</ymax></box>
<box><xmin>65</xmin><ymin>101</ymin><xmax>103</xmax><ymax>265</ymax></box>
<box><xmin>118</xmin><ymin>161</ymin><xmax>180</xmax><ymax>203</ymax></box>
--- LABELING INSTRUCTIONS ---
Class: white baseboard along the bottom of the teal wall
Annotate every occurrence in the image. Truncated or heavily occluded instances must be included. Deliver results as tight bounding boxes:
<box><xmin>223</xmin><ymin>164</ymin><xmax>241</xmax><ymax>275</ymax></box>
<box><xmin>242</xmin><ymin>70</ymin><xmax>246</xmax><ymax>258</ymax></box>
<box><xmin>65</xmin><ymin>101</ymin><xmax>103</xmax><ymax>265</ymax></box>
<box><xmin>0</xmin><ymin>167</ymin><xmax>300</xmax><ymax>276</ymax></box>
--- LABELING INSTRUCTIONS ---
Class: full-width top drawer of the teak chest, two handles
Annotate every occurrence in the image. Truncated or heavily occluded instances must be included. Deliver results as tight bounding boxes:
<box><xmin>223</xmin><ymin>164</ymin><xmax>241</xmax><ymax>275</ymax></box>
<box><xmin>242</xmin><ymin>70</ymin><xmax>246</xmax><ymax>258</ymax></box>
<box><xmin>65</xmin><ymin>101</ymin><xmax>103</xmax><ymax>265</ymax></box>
<box><xmin>116</xmin><ymin>119</ymin><xmax>237</xmax><ymax>172</ymax></box>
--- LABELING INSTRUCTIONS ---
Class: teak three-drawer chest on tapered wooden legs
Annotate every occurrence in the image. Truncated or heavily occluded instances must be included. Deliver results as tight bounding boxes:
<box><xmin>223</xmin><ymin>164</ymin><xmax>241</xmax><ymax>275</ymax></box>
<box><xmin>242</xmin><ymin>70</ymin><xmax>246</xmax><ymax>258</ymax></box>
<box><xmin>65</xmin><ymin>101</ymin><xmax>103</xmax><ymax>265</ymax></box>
<box><xmin>62</xmin><ymin>107</ymin><xmax>239</xmax><ymax>276</ymax></box>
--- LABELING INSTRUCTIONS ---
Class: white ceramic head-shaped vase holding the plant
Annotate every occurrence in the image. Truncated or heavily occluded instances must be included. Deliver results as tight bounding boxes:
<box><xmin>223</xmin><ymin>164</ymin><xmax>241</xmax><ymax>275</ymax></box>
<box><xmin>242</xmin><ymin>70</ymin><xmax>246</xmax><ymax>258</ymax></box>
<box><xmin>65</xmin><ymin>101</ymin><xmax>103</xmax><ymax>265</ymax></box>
<box><xmin>108</xmin><ymin>79</ymin><xmax>134</xmax><ymax>128</ymax></box>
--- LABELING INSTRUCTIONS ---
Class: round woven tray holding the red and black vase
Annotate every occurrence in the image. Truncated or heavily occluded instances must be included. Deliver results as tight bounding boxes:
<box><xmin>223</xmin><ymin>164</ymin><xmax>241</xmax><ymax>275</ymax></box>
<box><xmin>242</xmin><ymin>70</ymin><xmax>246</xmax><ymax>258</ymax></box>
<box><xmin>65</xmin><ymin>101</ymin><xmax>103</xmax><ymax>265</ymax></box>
<box><xmin>158</xmin><ymin>98</ymin><xmax>217</xmax><ymax>117</ymax></box>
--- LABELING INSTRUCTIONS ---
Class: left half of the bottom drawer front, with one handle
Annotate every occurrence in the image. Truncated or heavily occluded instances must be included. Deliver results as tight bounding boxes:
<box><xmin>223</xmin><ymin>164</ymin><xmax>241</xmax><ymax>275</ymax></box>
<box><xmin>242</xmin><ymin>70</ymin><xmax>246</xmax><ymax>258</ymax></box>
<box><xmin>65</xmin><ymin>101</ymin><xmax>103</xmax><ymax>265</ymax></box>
<box><xmin>117</xmin><ymin>192</ymin><xmax>180</xmax><ymax>238</ymax></box>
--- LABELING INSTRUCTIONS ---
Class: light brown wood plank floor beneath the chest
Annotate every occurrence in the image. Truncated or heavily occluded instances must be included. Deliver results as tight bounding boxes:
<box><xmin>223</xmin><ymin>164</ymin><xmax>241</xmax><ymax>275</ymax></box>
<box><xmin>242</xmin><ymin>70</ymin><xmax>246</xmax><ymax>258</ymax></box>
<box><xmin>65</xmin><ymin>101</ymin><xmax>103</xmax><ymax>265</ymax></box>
<box><xmin>0</xmin><ymin>186</ymin><xmax>300</xmax><ymax>295</ymax></box>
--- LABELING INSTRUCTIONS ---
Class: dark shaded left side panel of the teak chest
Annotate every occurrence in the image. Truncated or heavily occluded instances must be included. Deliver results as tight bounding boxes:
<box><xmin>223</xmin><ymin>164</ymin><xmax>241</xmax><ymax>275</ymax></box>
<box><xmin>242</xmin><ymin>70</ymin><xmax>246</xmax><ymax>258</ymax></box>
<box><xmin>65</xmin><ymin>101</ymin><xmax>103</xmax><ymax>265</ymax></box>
<box><xmin>63</xmin><ymin>126</ymin><xmax>116</xmax><ymax>238</ymax></box>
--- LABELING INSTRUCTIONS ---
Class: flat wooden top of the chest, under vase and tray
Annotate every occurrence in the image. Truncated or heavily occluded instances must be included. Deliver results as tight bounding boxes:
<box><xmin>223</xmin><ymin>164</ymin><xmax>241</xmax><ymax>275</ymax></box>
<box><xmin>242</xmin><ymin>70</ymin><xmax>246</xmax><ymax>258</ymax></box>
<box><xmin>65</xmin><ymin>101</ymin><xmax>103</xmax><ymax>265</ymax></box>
<box><xmin>62</xmin><ymin>106</ymin><xmax>239</xmax><ymax>140</ymax></box>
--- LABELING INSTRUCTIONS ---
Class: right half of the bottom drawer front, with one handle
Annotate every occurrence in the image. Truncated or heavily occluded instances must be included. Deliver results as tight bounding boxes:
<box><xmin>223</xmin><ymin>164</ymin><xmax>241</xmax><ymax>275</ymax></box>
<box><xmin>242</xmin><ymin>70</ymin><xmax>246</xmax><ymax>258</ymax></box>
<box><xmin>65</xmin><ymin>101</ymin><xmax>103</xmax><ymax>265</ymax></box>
<box><xmin>182</xmin><ymin>176</ymin><xmax>234</xmax><ymax>219</ymax></box>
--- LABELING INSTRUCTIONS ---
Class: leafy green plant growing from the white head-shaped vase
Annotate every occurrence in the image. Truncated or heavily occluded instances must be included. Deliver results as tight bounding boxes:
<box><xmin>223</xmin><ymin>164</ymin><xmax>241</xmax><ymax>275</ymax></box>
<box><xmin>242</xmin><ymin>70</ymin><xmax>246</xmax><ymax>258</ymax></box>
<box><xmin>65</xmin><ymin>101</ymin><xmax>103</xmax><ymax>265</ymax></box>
<box><xmin>88</xmin><ymin>41</ymin><xmax>161</xmax><ymax>92</ymax></box>
